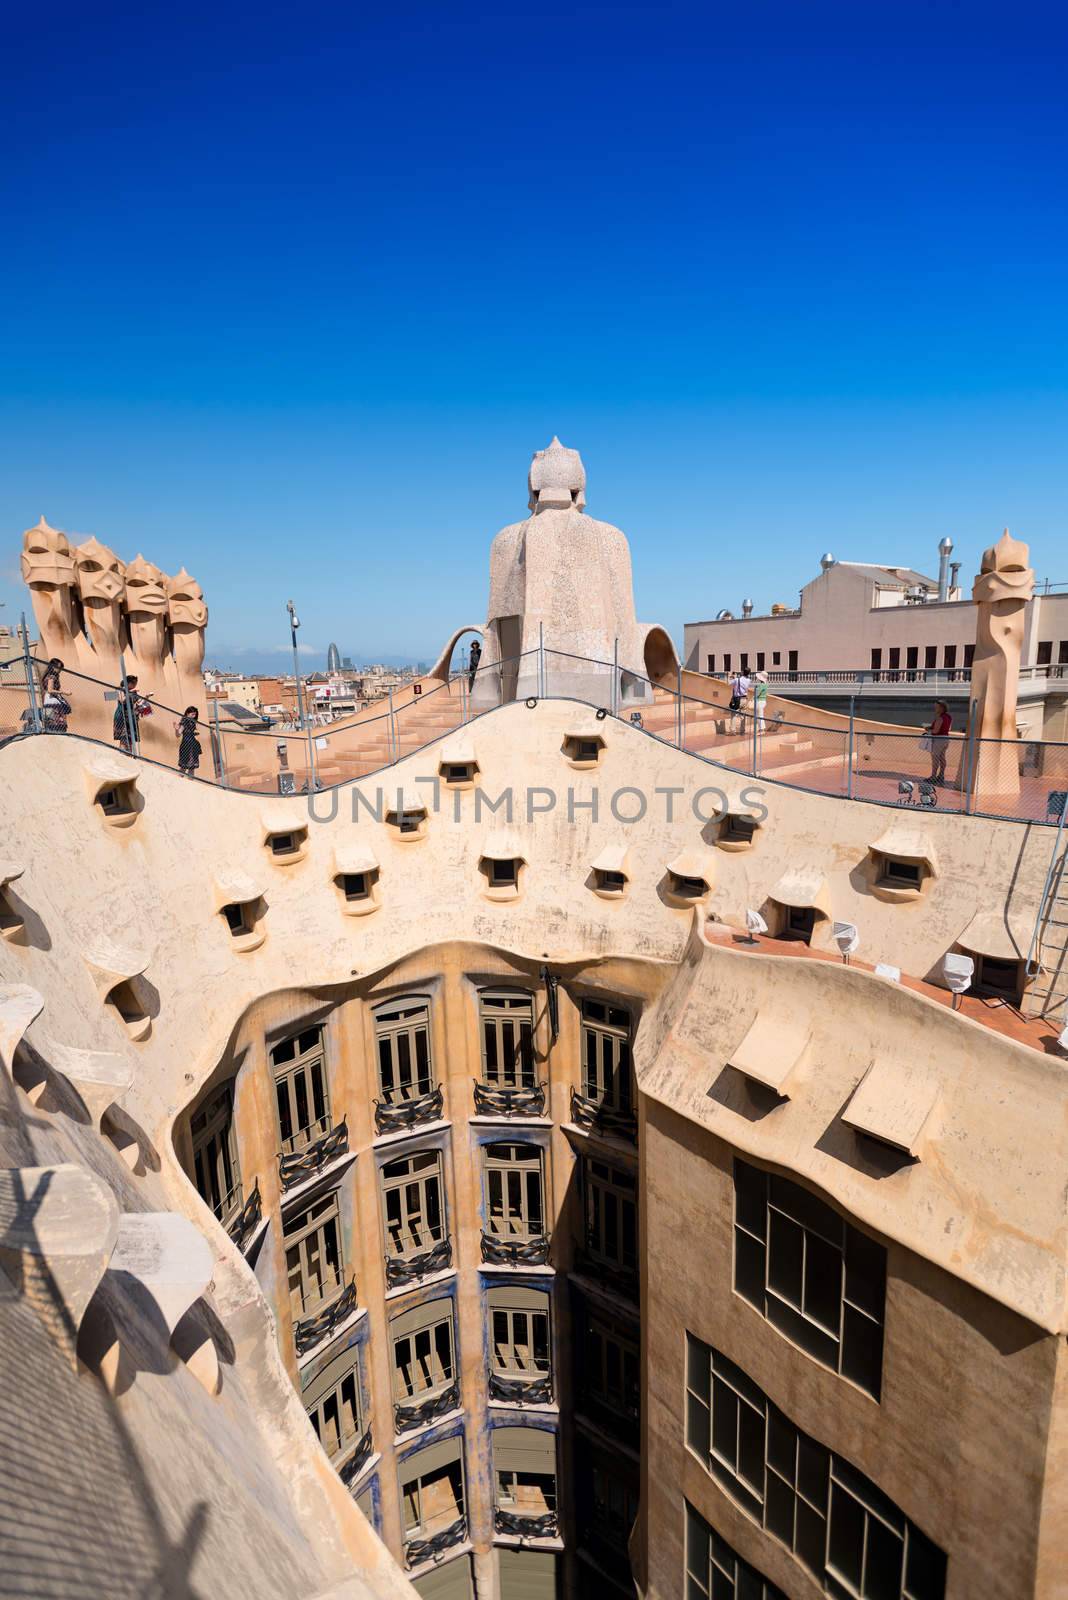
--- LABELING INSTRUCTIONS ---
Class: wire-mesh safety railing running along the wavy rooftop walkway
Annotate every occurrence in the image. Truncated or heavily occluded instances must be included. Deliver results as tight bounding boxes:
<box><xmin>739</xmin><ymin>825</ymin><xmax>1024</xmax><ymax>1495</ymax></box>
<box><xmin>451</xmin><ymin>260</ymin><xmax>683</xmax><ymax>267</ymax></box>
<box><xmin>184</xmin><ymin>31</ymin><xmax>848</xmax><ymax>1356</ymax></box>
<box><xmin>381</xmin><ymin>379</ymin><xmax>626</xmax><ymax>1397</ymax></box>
<box><xmin>0</xmin><ymin>627</ymin><xmax>1068</xmax><ymax>826</ymax></box>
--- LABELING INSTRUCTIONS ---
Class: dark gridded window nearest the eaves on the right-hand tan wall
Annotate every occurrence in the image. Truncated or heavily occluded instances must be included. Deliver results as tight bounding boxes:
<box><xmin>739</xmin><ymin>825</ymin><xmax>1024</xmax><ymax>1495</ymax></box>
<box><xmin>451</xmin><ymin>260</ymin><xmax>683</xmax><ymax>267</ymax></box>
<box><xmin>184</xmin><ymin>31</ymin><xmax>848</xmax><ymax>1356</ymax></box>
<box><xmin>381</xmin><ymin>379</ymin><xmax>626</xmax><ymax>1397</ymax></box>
<box><xmin>734</xmin><ymin>1158</ymin><xmax>886</xmax><ymax>1400</ymax></box>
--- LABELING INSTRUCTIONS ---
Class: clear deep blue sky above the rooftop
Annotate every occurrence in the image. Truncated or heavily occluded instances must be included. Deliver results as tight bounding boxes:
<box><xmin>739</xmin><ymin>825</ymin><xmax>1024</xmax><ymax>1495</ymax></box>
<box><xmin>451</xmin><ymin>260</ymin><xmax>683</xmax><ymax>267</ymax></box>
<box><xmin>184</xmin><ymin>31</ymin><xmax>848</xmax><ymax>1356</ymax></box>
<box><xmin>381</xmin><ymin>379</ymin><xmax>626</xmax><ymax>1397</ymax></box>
<box><xmin>0</xmin><ymin>0</ymin><xmax>1068</xmax><ymax>666</ymax></box>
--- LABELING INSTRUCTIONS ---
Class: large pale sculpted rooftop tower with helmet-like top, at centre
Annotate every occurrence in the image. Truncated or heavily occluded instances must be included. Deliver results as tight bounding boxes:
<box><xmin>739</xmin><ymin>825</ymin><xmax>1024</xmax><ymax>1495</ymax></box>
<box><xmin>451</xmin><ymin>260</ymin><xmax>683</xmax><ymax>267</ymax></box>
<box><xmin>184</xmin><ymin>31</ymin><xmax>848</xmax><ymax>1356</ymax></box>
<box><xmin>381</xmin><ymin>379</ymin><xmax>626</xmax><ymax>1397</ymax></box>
<box><xmin>470</xmin><ymin>438</ymin><xmax>678</xmax><ymax>706</ymax></box>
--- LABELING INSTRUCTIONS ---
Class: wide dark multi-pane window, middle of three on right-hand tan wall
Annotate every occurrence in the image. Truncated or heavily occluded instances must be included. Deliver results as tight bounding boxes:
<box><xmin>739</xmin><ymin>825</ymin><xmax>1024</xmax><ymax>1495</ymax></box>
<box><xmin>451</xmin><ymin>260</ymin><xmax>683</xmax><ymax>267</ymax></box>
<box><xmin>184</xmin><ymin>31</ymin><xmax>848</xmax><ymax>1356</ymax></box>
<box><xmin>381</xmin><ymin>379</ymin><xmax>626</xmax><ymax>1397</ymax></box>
<box><xmin>686</xmin><ymin>1334</ymin><xmax>946</xmax><ymax>1600</ymax></box>
